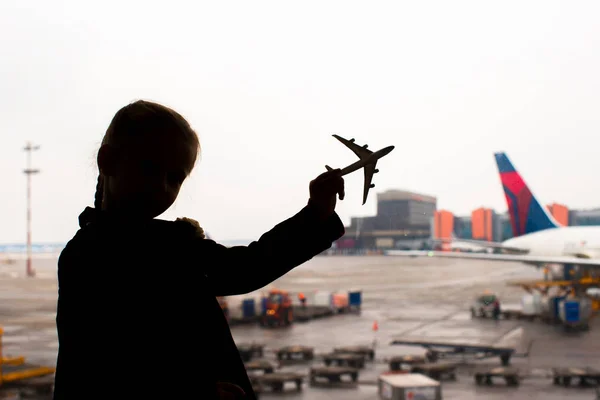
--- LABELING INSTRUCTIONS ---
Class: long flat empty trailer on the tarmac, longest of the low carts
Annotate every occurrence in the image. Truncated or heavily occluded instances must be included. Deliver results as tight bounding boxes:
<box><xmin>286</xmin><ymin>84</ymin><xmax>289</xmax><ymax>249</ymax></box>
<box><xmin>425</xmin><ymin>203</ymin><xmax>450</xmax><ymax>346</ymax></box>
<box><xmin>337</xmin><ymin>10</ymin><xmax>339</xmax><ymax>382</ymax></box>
<box><xmin>391</xmin><ymin>339</ymin><xmax>515</xmax><ymax>365</ymax></box>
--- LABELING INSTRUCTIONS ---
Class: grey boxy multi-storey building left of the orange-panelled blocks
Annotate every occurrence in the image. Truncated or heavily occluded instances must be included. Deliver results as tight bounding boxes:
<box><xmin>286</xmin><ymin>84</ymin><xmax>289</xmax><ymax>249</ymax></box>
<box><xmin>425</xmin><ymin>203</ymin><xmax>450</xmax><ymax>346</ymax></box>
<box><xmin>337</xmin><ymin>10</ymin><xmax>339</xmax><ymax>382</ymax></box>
<box><xmin>338</xmin><ymin>190</ymin><xmax>437</xmax><ymax>249</ymax></box>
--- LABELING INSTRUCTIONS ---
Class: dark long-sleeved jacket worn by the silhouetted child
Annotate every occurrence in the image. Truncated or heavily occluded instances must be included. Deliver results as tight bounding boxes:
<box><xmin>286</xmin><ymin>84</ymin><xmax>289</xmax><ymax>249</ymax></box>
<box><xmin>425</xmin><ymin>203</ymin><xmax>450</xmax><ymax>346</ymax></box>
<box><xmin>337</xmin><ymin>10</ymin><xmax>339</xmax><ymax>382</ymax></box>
<box><xmin>54</xmin><ymin>206</ymin><xmax>344</xmax><ymax>400</ymax></box>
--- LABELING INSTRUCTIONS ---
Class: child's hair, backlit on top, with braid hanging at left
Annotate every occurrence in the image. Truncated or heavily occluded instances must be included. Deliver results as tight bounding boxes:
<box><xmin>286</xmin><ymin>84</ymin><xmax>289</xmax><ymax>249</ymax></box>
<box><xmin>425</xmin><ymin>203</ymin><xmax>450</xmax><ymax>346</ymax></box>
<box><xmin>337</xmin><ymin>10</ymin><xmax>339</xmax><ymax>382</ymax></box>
<box><xmin>94</xmin><ymin>100</ymin><xmax>200</xmax><ymax>210</ymax></box>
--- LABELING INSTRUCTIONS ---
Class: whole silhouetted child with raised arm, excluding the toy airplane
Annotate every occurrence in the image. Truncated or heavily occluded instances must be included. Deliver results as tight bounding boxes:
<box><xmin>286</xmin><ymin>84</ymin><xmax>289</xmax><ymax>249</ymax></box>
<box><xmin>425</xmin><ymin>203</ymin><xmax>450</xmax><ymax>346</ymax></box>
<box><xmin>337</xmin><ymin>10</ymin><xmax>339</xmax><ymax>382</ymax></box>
<box><xmin>54</xmin><ymin>101</ymin><xmax>344</xmax><ymax>400</ymax></box>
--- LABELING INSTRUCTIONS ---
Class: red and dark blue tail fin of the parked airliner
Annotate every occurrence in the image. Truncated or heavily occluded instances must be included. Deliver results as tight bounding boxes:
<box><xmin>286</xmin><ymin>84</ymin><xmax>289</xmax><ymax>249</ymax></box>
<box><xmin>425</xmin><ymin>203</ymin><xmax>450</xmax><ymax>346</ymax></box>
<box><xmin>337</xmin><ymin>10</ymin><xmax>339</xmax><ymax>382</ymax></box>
<box><xmin>494</xmin><ymin>152</ymin><xmax>560</xmax><ymax>237</ymax></box>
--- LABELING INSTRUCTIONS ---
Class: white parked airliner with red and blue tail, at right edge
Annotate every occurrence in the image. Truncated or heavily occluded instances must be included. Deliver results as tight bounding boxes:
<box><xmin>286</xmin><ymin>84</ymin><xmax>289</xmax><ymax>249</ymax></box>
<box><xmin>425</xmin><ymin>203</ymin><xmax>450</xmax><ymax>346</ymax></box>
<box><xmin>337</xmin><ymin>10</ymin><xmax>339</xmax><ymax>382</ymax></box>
<box><xmin>386</xmin><ymin>153</ymin><xmax>600</xmax><ymax>276</ymax></box>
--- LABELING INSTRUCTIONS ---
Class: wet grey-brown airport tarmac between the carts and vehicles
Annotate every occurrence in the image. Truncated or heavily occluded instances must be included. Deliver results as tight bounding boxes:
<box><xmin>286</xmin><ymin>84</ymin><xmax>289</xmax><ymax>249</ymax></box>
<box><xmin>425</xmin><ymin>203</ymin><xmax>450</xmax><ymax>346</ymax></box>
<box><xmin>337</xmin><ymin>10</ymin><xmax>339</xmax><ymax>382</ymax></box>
<box><xmin>0</xmin><ymin>256</ymin><xmax>600</xmax><ymax>400</ymax></box>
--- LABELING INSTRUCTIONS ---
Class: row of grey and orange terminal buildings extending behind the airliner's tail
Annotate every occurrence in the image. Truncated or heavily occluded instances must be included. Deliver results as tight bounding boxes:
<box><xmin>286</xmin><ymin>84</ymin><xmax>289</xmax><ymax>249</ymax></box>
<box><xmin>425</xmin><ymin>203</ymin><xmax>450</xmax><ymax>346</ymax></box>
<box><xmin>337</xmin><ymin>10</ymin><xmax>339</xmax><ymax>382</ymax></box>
<box><xmin>334</xmin><ymin>190</ymin><xmax>600</xmax><ymax>250</ymax></box>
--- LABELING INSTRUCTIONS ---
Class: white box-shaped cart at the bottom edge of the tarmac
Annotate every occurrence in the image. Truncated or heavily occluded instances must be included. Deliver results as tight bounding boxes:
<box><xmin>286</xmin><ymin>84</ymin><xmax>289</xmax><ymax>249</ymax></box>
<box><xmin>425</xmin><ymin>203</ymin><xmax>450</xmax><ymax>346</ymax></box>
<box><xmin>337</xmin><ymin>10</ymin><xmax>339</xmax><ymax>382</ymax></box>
<box><xmin>378</xmin><ymin>374</ymin><xmax>442</xmax><ymax>400</ymax></box>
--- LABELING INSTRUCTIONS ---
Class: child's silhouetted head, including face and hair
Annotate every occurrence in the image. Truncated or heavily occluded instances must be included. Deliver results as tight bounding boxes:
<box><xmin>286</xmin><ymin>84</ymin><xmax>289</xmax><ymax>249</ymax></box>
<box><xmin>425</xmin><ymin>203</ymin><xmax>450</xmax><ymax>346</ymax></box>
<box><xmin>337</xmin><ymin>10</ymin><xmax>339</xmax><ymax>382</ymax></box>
<box><xmin>94</xmin><ymin>100</ymin><xmax>200</xmax><ymax>218</ymax></box>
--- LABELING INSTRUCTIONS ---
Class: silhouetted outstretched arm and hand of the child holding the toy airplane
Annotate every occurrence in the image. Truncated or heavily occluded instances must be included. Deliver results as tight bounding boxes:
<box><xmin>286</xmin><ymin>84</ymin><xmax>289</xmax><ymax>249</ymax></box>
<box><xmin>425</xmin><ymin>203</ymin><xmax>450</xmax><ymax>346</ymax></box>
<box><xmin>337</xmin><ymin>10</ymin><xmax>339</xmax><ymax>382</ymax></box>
<box><xmin>188</xmin><ymin>170</ymin><xmax>345</xmax><ymax>296</ymax></box>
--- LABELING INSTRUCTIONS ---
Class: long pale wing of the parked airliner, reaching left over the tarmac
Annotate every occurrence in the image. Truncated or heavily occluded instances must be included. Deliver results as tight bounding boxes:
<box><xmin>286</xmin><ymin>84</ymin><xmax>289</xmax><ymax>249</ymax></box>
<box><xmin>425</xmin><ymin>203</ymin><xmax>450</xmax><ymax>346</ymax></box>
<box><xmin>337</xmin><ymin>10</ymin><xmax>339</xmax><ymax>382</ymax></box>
<box><xmin>385</xmin><ymin>250</ymin><xmax>600</xmax><ymax>268</ymax></box>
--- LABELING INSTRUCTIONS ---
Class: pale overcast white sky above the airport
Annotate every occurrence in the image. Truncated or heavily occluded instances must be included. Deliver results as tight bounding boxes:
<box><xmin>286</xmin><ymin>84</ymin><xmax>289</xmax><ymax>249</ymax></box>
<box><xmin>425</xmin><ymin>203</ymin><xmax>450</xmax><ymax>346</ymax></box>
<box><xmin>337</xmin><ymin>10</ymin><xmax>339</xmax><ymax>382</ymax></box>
<box><xmin>0</xmin><ymin>0</ymin><xmax>600</xmax><ymax>243</ymax></box>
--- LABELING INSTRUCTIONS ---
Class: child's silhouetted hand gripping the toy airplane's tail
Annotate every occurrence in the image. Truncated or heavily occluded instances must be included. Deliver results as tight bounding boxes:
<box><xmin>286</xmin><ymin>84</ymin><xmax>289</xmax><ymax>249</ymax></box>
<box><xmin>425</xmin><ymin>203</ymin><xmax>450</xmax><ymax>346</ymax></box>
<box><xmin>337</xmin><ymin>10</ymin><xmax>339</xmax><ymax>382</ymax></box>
<box><xmin>308</xmin><ymin>169</ymin><xmax>345</xmax><ymax>219</ymax></box>
